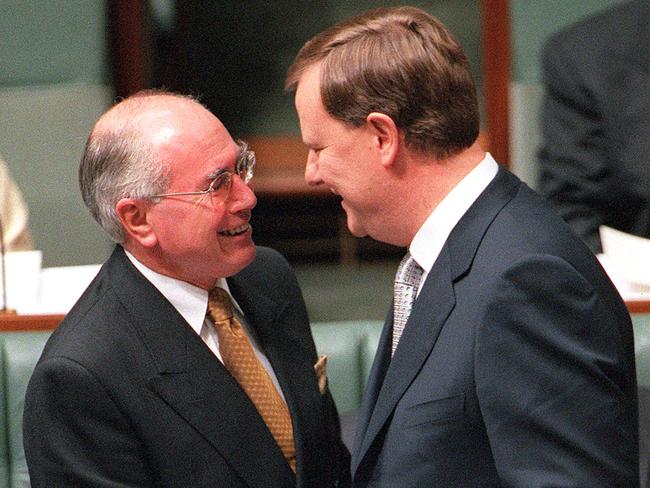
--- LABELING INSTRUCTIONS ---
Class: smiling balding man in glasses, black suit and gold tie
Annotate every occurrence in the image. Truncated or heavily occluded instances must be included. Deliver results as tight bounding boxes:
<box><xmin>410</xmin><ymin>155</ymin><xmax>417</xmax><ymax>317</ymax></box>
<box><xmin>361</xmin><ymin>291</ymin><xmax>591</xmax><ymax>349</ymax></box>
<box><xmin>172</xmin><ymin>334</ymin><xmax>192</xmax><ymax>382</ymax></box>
<box><xmin>24</xmin><ymin>92</ymin><xmax>349</xmax><ymax>488</ymax></box>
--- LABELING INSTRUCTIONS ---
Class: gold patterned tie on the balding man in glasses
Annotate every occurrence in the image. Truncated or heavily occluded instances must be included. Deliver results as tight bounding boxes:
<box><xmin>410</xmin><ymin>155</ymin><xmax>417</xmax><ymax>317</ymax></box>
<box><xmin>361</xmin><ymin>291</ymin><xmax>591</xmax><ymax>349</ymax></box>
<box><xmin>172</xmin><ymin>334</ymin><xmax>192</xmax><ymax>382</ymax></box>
<box><xmin>208</xmin><ymin>288</ymin><xmax>296</xmax><ymax>473</ymax></box>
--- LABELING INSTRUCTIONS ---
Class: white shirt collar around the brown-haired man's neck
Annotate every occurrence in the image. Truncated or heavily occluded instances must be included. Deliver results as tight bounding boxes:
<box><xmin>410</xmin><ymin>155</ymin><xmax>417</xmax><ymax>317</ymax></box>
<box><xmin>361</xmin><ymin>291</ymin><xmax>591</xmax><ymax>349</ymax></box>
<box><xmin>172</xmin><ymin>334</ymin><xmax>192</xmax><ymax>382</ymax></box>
<box><xmin>409</xmin><ymin>153</ymin><xmax>499</xmax><ymax>274</ymax></box>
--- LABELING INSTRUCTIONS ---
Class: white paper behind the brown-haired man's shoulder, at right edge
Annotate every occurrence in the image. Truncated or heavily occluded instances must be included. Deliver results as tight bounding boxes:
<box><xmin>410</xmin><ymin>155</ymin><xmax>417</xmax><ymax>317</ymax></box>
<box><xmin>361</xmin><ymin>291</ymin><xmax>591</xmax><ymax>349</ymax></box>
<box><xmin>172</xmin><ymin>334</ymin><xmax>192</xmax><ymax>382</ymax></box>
<box><xmin>598</xmin><ymin>226</ymin><xmax>650</xmax><ymax>300</ymax></box>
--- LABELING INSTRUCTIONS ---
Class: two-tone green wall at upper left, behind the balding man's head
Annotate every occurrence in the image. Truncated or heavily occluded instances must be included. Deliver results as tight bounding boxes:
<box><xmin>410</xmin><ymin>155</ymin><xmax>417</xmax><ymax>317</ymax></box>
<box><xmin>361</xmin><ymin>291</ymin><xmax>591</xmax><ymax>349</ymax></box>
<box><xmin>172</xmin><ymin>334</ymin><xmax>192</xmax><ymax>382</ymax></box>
<box><xmin>0</xmin><ymin>0</ymin><xmax>112</xmax><ymax>266</ymax></box>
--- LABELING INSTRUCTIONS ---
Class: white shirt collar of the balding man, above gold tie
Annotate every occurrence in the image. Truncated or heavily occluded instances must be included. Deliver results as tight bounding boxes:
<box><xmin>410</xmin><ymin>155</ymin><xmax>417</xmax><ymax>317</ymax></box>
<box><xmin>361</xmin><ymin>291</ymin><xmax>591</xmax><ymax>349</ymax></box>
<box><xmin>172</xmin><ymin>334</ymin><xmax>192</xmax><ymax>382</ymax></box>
<box><xmin>124</xmin><ymin>249</ymin><xmax>243</xmax><ymax>335</ymax></box>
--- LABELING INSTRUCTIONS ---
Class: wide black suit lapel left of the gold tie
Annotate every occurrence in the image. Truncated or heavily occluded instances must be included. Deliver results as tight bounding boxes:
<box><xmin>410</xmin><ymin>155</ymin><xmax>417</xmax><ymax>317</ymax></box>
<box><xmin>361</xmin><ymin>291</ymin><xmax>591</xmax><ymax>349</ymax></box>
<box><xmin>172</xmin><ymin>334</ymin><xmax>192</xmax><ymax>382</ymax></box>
<box><xmin>107</xmin><ymin>248</ymin><xmax>294</xmax><ymax>488</ymax></box>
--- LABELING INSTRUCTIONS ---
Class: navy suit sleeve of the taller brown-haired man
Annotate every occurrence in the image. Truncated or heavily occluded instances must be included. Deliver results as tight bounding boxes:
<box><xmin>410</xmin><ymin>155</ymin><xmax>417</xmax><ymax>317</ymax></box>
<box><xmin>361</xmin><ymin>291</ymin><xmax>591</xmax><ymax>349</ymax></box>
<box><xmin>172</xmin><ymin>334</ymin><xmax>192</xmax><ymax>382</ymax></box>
<box><xmin>475</xmin><ymin>256</ymin><xmax>638</xmax><ymax>488</ymax></box>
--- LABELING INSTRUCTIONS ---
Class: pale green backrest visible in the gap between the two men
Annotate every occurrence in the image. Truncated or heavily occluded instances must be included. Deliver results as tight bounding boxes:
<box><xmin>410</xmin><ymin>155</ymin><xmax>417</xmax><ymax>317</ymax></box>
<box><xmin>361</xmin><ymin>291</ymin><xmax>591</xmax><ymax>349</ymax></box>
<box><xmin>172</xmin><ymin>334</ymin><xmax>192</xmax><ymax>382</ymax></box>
<box><xmin>312</xmin><ymin>320</ymin><xmax>383</xmax><ymax>413</ymax></box>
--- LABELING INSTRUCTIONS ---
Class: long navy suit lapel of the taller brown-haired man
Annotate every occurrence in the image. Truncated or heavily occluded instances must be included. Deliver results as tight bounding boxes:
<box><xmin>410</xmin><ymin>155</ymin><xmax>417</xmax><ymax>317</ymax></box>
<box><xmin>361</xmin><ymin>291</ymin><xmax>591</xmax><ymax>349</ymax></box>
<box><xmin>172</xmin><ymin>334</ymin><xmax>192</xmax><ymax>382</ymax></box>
<box><xmin>352</xmin><ymin>168</ymin><xmax>521</xmax><ymax>475</ymax></box>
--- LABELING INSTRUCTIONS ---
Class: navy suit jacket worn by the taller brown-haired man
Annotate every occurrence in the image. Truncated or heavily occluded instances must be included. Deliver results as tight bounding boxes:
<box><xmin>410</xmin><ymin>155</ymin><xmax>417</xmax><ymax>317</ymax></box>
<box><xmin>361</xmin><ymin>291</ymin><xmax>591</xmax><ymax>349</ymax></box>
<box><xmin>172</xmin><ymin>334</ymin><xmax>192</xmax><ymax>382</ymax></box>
<box><xmin>352</xmin><ymin>169</ymin><xmax>638</xmax><ymax>488</ymax></box>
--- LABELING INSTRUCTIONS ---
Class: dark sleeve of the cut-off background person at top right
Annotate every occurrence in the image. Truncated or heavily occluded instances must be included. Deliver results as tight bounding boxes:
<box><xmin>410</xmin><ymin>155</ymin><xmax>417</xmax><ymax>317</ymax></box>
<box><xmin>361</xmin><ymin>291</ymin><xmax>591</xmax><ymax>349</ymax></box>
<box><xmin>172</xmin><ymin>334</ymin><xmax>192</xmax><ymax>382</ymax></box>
<box><xmin>539</xmin><ymin>37</ymin><xmax>609</xmax><ymax>252</ymax></box>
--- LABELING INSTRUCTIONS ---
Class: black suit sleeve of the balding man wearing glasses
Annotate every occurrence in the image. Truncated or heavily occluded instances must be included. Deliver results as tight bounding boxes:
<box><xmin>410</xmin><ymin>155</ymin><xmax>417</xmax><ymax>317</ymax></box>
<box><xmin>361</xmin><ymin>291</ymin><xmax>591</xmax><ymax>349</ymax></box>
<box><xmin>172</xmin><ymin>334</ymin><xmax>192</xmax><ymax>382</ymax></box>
<box><xmin>23</xmin><ymin>358</ymin><xmax>153</xmax><ymax>488</ymax></box>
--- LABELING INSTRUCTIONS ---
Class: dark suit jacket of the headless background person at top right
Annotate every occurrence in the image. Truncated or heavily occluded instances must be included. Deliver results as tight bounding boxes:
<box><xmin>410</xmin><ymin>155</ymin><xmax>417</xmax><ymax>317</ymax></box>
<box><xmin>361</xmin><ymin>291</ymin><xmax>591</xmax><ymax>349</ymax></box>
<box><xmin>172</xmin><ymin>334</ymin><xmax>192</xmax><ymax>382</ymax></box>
<box><xmin>540</xmin><ymin>0</ymin><xmax>650</xmax><ymax>252</ymax></box>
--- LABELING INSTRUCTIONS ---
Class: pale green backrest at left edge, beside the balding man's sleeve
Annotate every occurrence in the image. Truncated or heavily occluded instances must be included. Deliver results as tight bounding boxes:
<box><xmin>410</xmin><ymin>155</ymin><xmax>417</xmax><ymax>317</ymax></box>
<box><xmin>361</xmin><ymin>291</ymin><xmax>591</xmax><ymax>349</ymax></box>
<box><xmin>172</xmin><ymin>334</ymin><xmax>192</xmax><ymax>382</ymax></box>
<box><xmin>0</xmin><ymin>332</ymin><xmax>50</xmax><ymax>488</ymax></box>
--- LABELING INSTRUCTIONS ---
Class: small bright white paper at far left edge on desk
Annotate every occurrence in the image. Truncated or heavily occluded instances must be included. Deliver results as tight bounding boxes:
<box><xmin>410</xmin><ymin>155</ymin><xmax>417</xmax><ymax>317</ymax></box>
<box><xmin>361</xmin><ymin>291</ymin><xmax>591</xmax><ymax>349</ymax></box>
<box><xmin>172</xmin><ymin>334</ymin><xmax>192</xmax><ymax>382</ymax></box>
<box><xmin>0</xmin><ymin>251</ymin><xmax>43</xmax><ymax>313</ymax></box>
